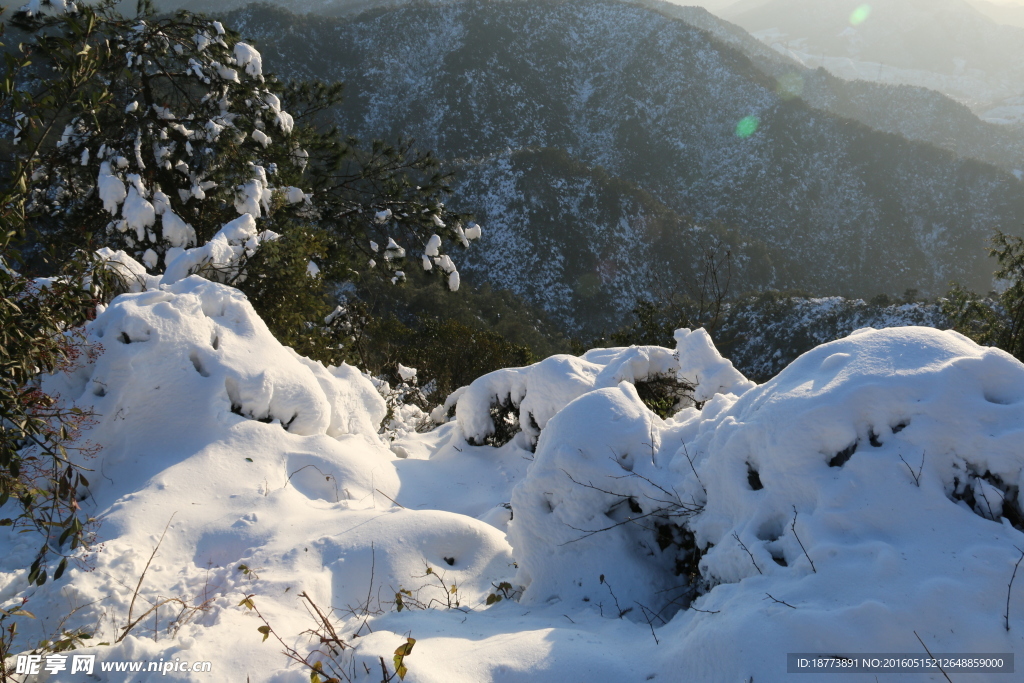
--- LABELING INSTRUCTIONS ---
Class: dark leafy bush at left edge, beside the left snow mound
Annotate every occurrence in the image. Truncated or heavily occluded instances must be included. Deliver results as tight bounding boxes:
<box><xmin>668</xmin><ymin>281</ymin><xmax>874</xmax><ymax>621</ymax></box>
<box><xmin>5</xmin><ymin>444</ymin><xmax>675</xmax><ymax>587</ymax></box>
<box><xmin>0</xmin><ymin>255</ymin><xmax>97</xmax><ymax>589</ymax></box>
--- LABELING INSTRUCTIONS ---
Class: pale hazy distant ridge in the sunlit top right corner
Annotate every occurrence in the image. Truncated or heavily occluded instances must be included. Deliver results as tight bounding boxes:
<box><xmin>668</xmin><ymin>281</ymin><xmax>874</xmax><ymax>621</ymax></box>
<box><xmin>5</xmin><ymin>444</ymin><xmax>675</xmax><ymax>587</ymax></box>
<box><xmin>721</xmin><ymin>0</ymin><xmax>1024</xmax><ymax>112</ymax></box>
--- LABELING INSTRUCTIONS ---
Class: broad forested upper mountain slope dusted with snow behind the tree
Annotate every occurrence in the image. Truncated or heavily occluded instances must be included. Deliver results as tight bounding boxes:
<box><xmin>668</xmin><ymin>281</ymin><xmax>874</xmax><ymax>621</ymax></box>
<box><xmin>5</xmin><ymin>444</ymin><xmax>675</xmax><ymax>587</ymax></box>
<box><xmin>232</xmin><ymin>1</ymin><xmax>1024</xmax><ymax>295</ymax></box>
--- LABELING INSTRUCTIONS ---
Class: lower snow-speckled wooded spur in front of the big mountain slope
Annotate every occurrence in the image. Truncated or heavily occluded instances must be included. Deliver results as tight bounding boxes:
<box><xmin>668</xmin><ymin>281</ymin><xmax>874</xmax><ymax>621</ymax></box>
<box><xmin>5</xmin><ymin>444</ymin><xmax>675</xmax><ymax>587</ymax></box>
<box><xmin>450</xmin><ymin>148</ymin><xmax>790</xmax><ymax>336</ymax></box>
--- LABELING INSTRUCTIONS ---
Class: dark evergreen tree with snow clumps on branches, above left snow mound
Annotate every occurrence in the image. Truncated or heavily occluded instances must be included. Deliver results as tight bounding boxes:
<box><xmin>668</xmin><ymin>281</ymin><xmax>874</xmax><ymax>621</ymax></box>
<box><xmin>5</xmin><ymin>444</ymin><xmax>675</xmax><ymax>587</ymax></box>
<box><xmin>6</xmin><ymin>0</ymin><xmax>480</xmax><ymax>335</ymax></box>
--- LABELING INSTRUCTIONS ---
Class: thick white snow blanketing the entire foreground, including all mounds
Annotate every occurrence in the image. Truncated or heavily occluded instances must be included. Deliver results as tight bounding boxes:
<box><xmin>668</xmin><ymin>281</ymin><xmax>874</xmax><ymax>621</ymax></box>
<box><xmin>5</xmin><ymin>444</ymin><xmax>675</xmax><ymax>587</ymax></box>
<box><xmin>0</xmin><ymin>276</ymin><xmax>1024</xmax><ymax>683</ymax></box>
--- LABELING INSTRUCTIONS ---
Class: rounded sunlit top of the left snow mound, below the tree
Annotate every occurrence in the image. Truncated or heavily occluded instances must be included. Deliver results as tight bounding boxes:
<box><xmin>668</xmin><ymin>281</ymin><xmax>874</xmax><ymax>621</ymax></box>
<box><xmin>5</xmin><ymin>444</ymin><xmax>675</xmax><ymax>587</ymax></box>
<box><xmin>82</xmin><ymin>275</ymin><xmax>386</xmax><ymax>437</ymax></box>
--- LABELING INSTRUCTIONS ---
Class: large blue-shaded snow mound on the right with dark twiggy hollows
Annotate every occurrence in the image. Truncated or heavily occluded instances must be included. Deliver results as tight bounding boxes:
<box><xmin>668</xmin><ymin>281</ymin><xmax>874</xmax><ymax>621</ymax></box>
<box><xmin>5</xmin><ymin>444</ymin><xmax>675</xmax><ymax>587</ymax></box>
<box><xmin>509</xmin><ymin>328</ymin><xmax>1024</xmax><ymax>681</ymax></box>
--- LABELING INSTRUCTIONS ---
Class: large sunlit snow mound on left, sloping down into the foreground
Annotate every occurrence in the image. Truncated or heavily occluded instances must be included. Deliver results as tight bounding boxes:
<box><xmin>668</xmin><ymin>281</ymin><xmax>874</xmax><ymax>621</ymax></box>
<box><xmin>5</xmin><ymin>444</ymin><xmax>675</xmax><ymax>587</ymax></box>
<box><xmin>0</xmin><ymin>275</ymin><xmax>520</xmax><ymax>680</ymax></box>
